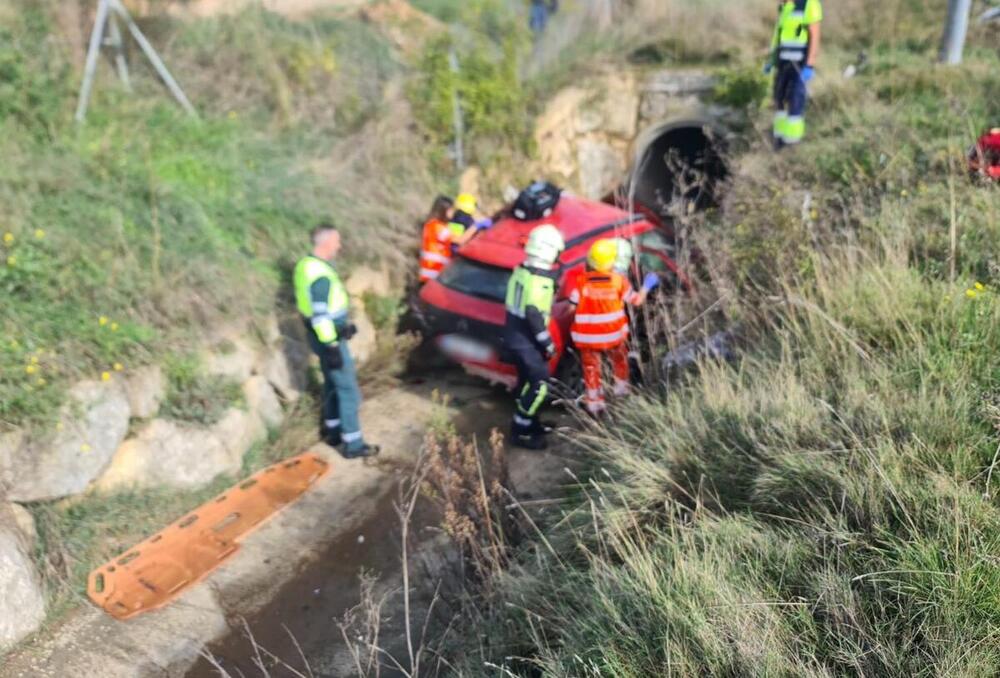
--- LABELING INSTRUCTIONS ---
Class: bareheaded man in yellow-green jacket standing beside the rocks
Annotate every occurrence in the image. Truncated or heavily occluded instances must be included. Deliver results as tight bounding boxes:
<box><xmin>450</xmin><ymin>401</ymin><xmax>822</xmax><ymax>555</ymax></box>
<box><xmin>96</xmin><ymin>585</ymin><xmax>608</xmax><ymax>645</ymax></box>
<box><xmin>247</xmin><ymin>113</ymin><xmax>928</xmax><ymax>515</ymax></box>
<box><xmin>294</xmin><ymin>224</ymin><xmax>379</xmax><ymax>459</ymax></box>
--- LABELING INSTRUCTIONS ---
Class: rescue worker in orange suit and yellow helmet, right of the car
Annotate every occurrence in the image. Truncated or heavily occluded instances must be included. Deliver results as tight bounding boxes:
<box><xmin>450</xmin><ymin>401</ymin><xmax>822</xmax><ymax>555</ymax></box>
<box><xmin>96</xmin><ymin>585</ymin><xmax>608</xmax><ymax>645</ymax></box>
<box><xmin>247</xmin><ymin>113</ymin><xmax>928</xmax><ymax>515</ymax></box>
<box><xmin>569</xmin><ymin>238</ymin><xmax>660</xmax><ymax>416</ymax></box>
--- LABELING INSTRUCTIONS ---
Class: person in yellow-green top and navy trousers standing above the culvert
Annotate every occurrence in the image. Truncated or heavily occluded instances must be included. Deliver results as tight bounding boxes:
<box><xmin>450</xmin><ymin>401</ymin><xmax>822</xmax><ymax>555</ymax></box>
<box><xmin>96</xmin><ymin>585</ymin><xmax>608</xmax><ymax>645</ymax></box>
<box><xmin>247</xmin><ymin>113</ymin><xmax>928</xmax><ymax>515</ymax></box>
<box><xmin>764</xmin><ymin>0</ymin><xmax>823</xmax><ymax>150</ymax></box>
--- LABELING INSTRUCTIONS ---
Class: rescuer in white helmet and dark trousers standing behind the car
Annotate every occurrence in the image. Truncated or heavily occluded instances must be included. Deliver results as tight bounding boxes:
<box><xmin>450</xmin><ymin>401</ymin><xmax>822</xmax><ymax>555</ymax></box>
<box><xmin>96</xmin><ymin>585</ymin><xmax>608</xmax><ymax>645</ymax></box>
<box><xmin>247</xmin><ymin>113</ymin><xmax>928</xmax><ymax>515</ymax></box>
<box><xmin>504</xmin><ymin>224</ymin><xmax>566</xmax><ymax>450</ymax></box>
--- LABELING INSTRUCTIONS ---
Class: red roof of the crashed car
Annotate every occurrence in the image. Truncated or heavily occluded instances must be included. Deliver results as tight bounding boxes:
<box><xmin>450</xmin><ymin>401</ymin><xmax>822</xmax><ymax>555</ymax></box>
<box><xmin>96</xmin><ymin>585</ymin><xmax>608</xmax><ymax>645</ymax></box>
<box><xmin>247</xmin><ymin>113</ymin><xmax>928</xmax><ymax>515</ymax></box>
<box><xmin>459</xmin><ymin>194</ymin><xmax>644</xmax><ymax>268</ymax></box>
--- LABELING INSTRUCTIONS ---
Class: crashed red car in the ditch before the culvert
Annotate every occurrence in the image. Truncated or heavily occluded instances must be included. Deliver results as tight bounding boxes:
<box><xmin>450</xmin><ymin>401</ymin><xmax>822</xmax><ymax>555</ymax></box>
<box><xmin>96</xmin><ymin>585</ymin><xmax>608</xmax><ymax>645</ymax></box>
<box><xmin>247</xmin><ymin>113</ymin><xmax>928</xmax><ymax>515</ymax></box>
<box><xmin>416</xmin><ymin>195</ymin><xmax>689</xmax><ymax>387</ymax></box>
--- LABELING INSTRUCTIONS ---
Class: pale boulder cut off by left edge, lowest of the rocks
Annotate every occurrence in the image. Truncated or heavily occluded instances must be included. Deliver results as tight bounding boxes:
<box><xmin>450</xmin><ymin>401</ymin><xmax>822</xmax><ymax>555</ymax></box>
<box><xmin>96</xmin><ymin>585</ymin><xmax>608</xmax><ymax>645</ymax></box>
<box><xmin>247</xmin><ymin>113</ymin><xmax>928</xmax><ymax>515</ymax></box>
<box><xmin>0</xmin><ymin>506</ymin><xmax>45</xmax><ymax>651</ymax></box>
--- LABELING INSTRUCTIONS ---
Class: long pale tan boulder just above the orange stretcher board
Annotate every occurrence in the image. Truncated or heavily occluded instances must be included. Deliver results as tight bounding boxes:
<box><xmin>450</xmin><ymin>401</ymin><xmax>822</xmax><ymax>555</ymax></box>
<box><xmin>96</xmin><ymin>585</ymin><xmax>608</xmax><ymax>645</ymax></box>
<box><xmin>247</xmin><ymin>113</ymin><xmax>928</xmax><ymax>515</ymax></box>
<box><xmin>96</xmin><ymin>408</ymin><xmax>267</xmax><ymax>491</ymax></box>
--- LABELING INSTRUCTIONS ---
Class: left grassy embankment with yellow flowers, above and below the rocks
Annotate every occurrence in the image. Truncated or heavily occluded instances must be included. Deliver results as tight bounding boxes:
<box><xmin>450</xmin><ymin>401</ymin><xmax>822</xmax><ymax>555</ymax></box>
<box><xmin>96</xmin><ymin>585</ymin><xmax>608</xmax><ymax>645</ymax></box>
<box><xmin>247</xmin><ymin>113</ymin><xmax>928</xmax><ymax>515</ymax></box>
<box><xmin>0</xmin><ymin>2</ymin><xmax>544</xmax><ymax>640</ymax></box>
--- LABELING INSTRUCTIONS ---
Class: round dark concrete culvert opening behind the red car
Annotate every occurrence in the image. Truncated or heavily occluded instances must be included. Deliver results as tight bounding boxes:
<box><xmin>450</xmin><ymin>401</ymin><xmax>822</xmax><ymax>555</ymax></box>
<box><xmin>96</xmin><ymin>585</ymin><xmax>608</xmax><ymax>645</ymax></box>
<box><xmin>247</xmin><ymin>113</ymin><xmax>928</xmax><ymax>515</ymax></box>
<box><xmin>618</xmin><ymin>119</ymin><xmax>728</xmax><ymax>223</ymax></box>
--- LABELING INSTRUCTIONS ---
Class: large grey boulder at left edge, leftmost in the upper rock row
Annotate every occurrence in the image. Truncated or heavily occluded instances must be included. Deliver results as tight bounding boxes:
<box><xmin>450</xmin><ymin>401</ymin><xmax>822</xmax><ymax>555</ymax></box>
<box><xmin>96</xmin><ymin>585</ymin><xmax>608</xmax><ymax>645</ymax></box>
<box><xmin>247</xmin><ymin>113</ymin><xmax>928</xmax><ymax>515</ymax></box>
<box><xmin>0</xmin><ymin>380</ymin><xmax>131</xmax><ymax>502</ymax></box>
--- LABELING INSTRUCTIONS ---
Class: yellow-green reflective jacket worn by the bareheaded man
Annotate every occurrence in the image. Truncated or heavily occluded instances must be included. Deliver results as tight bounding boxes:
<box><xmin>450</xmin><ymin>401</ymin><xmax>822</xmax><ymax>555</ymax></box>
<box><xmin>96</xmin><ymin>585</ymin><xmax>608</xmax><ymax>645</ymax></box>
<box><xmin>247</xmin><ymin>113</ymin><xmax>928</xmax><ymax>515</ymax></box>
<box><xmin>294</xmin><ymin>255</ymin><xmax>350</xmax><ymax>344</ymax></box>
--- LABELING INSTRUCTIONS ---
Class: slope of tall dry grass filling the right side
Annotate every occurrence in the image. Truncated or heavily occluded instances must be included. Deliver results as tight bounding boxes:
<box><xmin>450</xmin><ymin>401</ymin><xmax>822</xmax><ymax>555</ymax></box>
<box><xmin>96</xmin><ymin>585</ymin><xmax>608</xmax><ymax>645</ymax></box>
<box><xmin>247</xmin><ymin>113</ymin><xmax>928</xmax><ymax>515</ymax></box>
<box><xmin>436</xmin><ymin>3</ymin><xmax>1000</xmax><ymax>677</ymax></box>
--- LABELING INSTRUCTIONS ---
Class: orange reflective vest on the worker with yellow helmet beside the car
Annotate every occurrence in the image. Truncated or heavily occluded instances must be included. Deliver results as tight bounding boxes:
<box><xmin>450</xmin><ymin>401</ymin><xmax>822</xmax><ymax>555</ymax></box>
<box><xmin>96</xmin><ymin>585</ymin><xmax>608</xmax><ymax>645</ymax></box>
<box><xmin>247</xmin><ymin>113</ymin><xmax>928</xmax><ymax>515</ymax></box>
<box><xmin>569</xmin><ymin>271</ymin><xmax>632</xmax><ymax>350</ymax></box>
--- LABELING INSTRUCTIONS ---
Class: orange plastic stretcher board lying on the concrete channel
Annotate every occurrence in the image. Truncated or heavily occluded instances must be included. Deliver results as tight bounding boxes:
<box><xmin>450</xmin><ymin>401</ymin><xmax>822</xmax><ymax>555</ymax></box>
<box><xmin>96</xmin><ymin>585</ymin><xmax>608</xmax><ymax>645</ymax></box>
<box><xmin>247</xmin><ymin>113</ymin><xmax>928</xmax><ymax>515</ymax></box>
<box><xmin>87</xmin><ymin>453</ymin><xmax>329</xmax><ymax>619</ymax></box>
